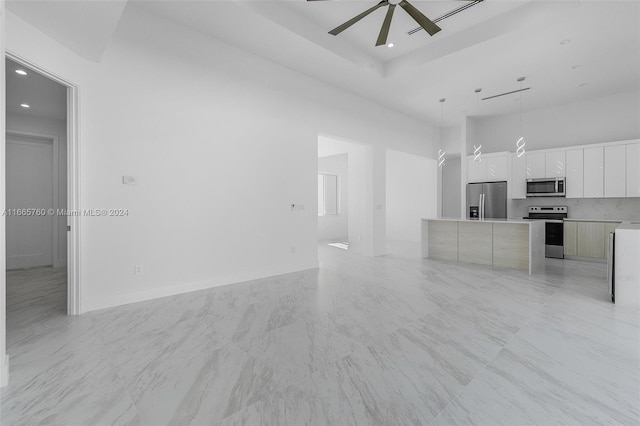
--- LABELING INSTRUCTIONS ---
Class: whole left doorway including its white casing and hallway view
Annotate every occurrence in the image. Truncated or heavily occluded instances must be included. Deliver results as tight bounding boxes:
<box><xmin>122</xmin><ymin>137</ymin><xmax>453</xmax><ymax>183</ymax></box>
<box><xmin>0</xmin><ymin>52</ymin><xmax>81</xmax><ymax>334</ymax></box>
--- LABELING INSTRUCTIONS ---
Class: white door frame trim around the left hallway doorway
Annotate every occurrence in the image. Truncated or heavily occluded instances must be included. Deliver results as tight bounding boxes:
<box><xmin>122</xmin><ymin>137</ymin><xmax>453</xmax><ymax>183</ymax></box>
<box><xmin>1</xmin><ymin>50</ymin><xmax>82</xmax><ymax>315</ymax></box>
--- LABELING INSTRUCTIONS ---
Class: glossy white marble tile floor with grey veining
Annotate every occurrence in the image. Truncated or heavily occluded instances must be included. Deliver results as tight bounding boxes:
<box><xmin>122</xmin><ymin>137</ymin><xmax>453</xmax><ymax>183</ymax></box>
<box><xmin>0</xmin><ymin>245</ymin><xmax>640</xmax><ymax>425</ymax></box>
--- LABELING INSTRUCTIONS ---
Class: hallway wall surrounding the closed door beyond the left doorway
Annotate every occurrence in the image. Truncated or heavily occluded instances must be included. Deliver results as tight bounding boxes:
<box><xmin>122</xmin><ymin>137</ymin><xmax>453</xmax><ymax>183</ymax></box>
<box><xmin>6</xmin><ymin>113</ymin><xmax>67</xmax><ymax>267</ymax></box>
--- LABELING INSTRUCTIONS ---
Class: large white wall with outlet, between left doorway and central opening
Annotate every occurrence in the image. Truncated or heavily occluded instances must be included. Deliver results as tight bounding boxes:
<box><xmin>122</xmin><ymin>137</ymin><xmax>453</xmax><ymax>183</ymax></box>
<box><xmin>7</xmin><ymin>6</ymin><xmax>435</xmax><ymax>311</ymax></box>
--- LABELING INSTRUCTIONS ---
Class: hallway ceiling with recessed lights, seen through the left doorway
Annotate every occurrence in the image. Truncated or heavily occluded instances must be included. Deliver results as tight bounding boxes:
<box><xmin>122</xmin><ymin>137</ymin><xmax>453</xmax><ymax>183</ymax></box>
<box><xmin>5</xmin><ymin>59</ymin><xmax>67</xmax><ymax>120</ymax></box>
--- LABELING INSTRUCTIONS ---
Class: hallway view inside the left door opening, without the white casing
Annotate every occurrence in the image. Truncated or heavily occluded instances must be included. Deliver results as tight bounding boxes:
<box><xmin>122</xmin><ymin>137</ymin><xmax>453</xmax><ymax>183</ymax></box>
<box><xmin>4</xmin><ymin>58</ymin><xmax>68</xmax><ymax>332</ymax></box>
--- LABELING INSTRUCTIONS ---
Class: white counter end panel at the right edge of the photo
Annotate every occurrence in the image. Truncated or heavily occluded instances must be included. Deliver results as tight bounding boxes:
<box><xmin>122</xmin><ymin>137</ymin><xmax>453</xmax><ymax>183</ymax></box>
<box><xmin>614</xmin><ymin>221</ymin><xmax>640</xmax><ymax>308</ymax></box>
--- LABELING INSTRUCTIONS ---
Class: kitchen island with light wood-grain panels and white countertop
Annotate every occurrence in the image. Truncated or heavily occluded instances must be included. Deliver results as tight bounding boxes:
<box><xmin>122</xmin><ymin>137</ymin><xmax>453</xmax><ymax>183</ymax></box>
<box><xmin>422</xmin><ymin>219</ymin><xmax>545</xmax><ymax>274</ymax></box>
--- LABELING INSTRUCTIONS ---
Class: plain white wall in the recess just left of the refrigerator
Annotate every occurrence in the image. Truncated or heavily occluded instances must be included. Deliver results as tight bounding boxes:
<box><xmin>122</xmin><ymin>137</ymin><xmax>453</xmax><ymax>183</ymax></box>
<box><xmin>386</xmin><ymin>150</ymin><xmax>437</xmax><ymax>241</ymax></box>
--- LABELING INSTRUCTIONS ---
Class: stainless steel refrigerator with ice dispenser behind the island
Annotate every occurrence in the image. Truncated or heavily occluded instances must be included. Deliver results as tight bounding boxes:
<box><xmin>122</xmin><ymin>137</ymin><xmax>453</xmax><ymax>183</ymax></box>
<box><xmin>467</xmin><ymin>182</ymin><xmax>507</xmax><ymax>219</ymax></box>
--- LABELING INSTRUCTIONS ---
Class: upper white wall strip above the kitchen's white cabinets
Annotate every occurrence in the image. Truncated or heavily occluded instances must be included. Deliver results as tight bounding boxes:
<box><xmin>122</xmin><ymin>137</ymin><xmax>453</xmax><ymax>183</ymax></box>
<box><xmin>473</xmin><ymin>91</ymin><xmax>640</xmax><ymax>153</ymax></box>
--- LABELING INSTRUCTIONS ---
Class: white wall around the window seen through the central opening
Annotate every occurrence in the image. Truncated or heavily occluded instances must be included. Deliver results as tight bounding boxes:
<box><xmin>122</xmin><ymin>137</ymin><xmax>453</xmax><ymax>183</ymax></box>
<box><xmin>318</xmin><ymin>153</ymin><xmax>349</xmax><ymax>241</ymax></box>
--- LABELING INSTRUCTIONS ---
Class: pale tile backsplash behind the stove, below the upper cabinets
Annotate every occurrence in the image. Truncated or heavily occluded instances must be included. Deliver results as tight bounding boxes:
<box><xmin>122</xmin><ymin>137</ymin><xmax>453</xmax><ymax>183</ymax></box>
<box><xmin>509</xmin><ymin>197</ymin><xmax>640</xmax><ymax>220</ymax></box>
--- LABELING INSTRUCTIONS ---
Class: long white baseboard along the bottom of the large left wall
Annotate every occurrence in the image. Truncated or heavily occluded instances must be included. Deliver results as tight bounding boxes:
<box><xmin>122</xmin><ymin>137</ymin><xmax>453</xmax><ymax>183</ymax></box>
<box><xmin>82</xmin><ymin>261</ymin><xmax>318</xmax><ymax>313</ymax></box>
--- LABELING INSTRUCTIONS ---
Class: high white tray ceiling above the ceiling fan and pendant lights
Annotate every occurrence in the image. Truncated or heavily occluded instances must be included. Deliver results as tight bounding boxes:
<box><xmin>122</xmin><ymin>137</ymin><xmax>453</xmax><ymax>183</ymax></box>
<box><xmin>7</xmin><ymin>0</ymin><xmax>640</xmax><ymax>125</ymax></box>
